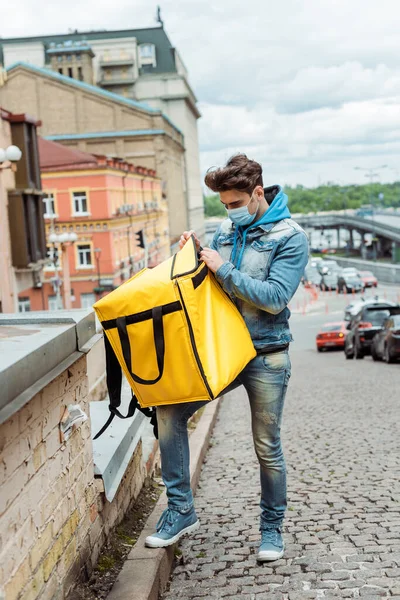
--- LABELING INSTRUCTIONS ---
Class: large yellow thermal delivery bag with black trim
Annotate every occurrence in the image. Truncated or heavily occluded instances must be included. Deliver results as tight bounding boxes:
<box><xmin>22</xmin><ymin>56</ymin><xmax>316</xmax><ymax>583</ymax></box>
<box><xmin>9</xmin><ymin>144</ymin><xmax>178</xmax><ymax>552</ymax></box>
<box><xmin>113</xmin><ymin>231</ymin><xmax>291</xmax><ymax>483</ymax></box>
<box><xmin>94</xmin><ymin>237</ymin><xmax>256</xmax><ymax>435</ymax></box>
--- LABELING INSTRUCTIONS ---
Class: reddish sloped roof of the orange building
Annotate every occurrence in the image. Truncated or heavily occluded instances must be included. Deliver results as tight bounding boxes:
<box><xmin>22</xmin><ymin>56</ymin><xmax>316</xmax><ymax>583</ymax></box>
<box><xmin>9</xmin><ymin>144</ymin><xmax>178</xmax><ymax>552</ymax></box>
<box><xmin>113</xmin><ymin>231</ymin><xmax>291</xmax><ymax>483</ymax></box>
<box><xmin>38</xmin><ymin>136</ymin><xmax>98</xmax><ymax>171</ymax></box>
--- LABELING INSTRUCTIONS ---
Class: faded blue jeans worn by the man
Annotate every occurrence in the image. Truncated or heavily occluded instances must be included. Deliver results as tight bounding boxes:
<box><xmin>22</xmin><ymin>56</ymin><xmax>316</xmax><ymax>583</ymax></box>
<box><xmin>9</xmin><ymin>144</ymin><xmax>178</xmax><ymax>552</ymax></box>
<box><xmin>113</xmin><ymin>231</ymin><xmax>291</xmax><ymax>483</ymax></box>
<box><xmin>157</xmin><ymin>350</ymin><xmax>291</xmax><ymax>529</ymax></box>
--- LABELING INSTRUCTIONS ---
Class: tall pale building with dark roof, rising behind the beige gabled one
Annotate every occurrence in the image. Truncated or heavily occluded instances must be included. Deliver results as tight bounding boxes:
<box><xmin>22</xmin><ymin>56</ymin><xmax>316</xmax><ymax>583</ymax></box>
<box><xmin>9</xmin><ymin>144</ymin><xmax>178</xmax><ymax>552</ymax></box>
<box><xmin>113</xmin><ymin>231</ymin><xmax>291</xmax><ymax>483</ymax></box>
<box><xmin>0</xmin><ymin>23</ymin><xmax>204</xmax><ymax>236</ymax></box>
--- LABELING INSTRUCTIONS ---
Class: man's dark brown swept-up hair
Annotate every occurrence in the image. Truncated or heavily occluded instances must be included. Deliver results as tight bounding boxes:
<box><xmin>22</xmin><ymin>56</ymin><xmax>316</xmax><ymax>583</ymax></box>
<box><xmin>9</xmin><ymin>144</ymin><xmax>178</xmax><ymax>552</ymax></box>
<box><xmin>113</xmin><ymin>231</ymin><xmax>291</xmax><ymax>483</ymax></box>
<box><xmin>204</xmin><ymin>154</ymin><xmax>263</xmax><ymax>194</ymax></box>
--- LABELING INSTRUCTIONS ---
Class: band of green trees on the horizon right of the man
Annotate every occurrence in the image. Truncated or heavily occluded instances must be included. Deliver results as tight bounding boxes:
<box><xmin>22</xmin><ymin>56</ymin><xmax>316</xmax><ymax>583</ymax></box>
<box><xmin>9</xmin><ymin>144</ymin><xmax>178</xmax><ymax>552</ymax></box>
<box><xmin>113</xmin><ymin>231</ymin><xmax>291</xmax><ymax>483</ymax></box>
<box><xmin>285</xmin><ymin>182</ymin><xmax>400</xmax><ymax>213</ymax></box>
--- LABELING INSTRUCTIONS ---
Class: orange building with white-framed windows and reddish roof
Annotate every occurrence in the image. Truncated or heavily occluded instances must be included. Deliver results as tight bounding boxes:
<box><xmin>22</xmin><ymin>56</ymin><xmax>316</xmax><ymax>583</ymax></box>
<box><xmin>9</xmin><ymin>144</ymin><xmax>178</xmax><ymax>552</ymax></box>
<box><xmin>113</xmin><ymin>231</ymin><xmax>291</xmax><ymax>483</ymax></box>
<box><xmin>20</xmin><ymin>139</ymin><xmax>170</xmax><ymax>310</ymax></box>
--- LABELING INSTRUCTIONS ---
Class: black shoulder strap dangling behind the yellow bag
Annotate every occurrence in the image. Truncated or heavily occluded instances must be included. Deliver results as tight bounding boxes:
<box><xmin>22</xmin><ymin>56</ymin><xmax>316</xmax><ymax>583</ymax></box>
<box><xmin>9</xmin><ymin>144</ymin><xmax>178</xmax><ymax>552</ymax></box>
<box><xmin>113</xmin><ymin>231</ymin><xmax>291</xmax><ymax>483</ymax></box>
<box><xmin>93</xmin><ymin>334</ymin><xmax>158</xmax><ymax>440</ymax></box>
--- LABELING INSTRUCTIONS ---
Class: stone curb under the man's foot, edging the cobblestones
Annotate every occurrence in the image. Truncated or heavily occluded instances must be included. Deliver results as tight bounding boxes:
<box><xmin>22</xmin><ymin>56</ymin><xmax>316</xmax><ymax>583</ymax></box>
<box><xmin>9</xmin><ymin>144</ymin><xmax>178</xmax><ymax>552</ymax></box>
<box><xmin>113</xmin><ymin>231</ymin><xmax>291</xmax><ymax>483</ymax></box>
<box><xmin>107</xmin><ymin>399</ymin><xmax>221</xmax><ymax>600</ymax></box>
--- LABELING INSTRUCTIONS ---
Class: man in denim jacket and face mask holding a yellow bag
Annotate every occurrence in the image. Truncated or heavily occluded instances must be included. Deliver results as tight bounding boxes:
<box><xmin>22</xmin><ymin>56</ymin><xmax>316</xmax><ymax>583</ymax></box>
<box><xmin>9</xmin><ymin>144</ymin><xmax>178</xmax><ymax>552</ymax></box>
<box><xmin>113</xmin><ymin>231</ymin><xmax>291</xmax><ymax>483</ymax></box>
<box><xmin>146</xmin><ymin>154</ymin><xmax>308</xmax><ymax>561</ymax></box>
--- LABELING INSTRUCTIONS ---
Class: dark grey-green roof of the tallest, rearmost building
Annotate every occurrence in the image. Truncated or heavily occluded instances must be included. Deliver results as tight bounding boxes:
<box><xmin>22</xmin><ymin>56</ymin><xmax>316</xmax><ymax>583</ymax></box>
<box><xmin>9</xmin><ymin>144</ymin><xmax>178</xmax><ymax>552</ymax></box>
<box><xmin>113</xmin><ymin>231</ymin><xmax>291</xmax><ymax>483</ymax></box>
<box><xmin>0</xmin><ymin>26</ymin><xmax>177</xmax><ymax>73</ymax></box>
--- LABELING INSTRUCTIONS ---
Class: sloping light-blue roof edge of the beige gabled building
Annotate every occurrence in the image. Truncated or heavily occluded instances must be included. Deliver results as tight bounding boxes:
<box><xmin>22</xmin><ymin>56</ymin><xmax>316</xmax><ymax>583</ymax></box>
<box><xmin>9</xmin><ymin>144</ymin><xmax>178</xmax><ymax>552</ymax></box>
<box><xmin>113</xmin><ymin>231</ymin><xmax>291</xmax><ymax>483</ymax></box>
<box><xmin>5</xmin><ymin>62</ymin><xmax>183</xmax><ymax>137</ymax></box>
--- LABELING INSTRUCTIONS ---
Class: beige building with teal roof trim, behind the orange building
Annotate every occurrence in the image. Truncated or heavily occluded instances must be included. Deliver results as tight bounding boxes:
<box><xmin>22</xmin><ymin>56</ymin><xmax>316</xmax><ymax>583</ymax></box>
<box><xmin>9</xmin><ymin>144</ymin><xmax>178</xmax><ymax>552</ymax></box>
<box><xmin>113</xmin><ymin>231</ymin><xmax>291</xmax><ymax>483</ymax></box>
<box><xmin>0</xmin><ymin>64</ymin><xmax>189</xmax><ymax>243</ymax></box>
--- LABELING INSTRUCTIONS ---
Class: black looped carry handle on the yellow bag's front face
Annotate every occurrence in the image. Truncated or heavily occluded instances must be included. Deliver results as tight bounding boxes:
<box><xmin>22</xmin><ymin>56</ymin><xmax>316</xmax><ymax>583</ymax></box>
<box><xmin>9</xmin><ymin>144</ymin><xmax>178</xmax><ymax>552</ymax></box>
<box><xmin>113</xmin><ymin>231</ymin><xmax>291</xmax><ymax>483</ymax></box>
<box><xmin>116</xmin><ymin>306</ymin><xmax>165</xmax><ymax>385</ymax></box>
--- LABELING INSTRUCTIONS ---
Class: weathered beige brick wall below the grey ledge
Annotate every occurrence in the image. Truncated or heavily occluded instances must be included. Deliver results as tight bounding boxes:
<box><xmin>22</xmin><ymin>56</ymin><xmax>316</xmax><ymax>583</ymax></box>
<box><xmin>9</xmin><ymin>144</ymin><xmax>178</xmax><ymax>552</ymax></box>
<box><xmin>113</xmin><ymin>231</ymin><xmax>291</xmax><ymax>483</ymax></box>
<box><xmin>0</xmin><ymin>340</ymin><xmax>153</xmax><ymax>600</ymax></box>
